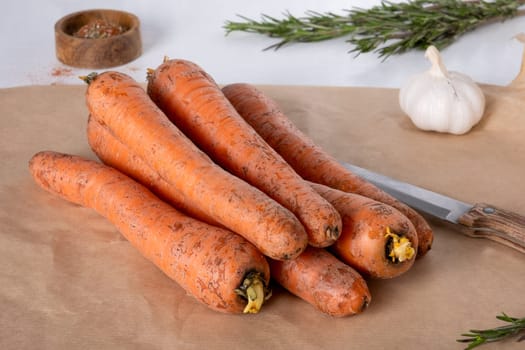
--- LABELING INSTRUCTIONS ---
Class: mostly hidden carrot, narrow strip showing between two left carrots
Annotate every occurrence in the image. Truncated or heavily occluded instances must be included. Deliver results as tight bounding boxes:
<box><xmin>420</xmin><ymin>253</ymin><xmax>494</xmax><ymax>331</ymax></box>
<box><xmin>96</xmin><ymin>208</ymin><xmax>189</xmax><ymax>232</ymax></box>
<box><xmin>87</xmin><ymin>115</ymin><xmax>217</xmax><ymax>226</ymax></box>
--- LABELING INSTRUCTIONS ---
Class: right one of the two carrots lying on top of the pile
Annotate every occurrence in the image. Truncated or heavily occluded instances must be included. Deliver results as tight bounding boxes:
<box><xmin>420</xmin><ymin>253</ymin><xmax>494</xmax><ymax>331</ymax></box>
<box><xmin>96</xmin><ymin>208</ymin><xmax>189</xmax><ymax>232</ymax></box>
<box><xmin>148</xmin><ymin>59</ymin><xmax>341</xmax><ymax>247</ymax></box>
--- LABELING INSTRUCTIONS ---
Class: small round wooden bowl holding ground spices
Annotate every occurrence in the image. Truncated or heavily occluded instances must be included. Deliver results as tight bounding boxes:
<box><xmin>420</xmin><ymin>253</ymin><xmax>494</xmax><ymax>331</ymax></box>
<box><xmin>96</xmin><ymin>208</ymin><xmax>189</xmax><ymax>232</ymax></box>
<box><xmin>55</xmin><ymin>10</ymin><xmax>142</xmax><ymax>68</ymax></box>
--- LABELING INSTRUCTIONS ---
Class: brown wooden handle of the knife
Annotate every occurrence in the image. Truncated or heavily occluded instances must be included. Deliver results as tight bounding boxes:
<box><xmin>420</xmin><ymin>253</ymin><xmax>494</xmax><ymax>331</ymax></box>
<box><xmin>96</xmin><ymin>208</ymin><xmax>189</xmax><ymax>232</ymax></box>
<box><xmin>458</xmin><ymin>203</ymin><xmax>525</xmax><ymax>253</ymax></box>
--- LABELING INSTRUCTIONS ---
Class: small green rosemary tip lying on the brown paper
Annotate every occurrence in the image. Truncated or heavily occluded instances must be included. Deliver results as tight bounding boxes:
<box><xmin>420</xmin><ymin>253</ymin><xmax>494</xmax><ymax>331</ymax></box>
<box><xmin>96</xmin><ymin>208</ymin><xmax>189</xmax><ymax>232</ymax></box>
<box><xmin>457</xmin><ymin>313</ymin><xmax>525</xmax><ymax>350</ymax></box>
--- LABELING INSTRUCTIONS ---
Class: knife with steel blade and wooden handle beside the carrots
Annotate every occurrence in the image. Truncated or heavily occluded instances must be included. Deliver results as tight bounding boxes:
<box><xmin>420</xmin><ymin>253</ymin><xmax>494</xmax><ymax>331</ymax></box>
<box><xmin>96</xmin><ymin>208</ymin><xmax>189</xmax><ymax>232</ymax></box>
<box><xmin>343</xmin><ymin>163</ymin><xmax>525</xmax><ymax>253</ymax></box>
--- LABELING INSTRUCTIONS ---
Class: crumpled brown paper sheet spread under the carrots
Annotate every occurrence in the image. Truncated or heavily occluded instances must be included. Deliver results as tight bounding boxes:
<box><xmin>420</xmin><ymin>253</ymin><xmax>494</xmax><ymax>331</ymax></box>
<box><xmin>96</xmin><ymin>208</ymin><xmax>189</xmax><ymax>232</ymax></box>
<box><xmin>0</xmin><ymin>86</ymin><xmax>525</xmax><ymax>350</ymax></box>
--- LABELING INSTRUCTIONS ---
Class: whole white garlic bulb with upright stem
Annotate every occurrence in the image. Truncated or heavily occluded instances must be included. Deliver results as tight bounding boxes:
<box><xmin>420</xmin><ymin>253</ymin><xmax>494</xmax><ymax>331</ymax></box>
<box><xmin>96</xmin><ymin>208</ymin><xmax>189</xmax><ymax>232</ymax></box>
<box><xmin>399</xmin><ymin>46</ymin><xmax>485</xmax><ymax>135</ymax></box>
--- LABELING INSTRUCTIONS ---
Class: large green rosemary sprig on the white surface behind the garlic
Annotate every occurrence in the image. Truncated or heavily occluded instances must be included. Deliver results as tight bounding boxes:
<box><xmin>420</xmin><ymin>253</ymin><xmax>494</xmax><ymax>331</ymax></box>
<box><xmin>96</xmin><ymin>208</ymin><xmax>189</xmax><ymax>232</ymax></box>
<box><xmin>224</xmin><ymin>0</ymin><xmax>525</xmax><ymax>58</ymax></box>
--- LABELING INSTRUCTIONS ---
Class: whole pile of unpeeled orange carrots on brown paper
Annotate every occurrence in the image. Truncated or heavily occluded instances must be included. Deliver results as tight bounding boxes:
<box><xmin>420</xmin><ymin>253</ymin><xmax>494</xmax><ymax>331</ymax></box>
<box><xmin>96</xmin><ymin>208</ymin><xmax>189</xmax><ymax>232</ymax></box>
<box><xmin>29</xmin><ymin>59</ymin><xmax>433</xmax><ymax>316</ymax></box>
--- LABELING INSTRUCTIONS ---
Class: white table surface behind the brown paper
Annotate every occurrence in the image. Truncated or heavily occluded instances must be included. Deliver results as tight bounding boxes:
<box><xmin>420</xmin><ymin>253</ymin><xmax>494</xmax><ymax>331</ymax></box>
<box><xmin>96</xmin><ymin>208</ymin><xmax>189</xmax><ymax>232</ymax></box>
<box><xmin>0</xmin><ymin>0</ymin><xmax>525</xmax><ymax>88</ymax></box>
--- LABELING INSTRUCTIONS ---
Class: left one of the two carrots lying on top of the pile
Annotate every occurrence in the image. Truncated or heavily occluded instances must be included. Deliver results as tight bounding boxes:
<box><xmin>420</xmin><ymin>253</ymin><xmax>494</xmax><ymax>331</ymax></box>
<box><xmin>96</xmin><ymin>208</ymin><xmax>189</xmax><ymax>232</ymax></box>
<box><xmin>86</xmin><ymin>72</ymin><xmax>308</xmax><ymax>260</ymax></box>
